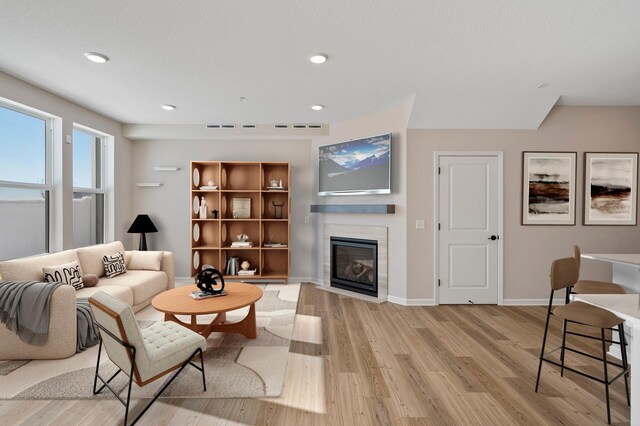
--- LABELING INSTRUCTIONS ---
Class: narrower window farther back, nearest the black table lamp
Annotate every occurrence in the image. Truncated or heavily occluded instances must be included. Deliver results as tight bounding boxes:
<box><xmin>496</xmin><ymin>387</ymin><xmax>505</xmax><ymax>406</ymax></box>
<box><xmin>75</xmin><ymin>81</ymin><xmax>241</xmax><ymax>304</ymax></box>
<box><xmin>73</xmin><ymin>126</ymin><xmax>105</xmax><ymax>247</ymax></box>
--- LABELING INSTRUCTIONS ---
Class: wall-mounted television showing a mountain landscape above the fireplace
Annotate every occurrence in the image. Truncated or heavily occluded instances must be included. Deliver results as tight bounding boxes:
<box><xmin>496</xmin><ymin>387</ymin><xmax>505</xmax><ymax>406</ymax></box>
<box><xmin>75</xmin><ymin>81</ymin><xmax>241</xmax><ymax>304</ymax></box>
<box><xmin>318</xmin><ymin>133</ymin><xmax>391</xmax><ymax>195</ymax></box>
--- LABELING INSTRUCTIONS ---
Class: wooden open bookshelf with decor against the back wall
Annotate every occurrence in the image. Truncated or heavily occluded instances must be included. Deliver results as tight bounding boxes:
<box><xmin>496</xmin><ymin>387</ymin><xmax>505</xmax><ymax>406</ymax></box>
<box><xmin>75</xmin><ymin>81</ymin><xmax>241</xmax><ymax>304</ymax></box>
<box><xmin>190</xmin><ymin>161</ymin><xmax>291</xmax><ymax>282</ymax></box>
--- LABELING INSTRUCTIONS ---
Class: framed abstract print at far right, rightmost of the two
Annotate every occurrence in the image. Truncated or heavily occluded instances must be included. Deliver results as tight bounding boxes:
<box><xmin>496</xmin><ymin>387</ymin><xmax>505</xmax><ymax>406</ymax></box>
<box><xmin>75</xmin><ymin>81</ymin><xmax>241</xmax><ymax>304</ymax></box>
<box><xmin>583</xmin><ymin>152</ymin><xmax>638</xmax><ymax>225</ymax></box>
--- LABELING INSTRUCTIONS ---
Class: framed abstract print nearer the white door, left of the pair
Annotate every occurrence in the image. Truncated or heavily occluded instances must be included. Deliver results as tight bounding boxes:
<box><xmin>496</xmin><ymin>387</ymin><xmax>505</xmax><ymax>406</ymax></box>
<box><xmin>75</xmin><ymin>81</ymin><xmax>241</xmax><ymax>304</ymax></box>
<box><xmin>522</xmin><ymin>151</ymin><xmax>578</xmax><ymax>226</ymax></box>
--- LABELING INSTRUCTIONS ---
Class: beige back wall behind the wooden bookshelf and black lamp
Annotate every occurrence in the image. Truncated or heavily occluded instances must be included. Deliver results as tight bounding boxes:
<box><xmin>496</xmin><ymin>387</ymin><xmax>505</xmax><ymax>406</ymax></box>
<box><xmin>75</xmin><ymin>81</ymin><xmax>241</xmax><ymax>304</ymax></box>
<box><xmin>132</xmin><ymin>140</ymin><xmax>312</xmax><ymax>279</ymax></box>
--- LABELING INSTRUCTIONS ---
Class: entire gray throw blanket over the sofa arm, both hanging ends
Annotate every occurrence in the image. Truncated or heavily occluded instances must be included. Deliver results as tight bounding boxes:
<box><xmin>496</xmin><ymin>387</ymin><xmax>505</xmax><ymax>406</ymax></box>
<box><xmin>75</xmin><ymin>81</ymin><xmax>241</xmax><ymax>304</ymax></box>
<box><xmin>0</xmin><ymin>281</ymin><xmax>100</xmax><ymax>352</ymax></box>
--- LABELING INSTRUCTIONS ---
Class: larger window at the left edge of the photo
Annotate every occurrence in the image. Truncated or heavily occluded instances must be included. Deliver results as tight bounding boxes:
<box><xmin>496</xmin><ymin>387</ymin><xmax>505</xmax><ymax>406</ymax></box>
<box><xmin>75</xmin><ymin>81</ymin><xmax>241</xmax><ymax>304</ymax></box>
<box><xmin>0</xmin><ymin>105</ymin><xmax>51</xmax><ymax>260</ymax></box>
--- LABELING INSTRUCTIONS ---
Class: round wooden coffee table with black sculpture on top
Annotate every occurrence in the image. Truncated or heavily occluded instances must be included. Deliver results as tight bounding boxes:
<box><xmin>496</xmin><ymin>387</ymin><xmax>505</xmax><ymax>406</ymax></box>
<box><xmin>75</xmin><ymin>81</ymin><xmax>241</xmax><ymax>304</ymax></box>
<box><xmin>151</xmin><ymin>282</ymin><xmax>262</xmax><ymax>339</ymax></box>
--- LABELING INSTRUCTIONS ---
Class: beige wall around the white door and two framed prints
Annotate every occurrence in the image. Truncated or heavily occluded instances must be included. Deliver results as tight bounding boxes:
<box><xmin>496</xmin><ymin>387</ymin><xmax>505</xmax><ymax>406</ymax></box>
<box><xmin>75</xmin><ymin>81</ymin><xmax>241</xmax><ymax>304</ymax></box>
<box><xmin>407</xmin><ymin>106</ymin><xmax>640</xmax><ymax>303</ymax></box>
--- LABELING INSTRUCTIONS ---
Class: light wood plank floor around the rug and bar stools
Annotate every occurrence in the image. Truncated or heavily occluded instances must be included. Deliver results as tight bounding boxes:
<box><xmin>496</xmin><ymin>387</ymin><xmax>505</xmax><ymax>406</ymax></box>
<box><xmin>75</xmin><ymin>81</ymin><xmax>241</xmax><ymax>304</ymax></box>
<box><xmin>0</xmin><ymin>284</ymin><xmax>629</xmax><ymax>426</ymax></box>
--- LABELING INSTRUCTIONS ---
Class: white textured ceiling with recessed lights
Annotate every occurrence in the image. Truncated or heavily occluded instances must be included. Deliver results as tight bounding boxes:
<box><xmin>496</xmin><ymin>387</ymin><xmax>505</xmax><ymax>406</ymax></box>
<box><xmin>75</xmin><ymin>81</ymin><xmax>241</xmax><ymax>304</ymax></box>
<box><xmin>0</xmin><ymin>0</ymin><xmax>640</xmax><ymax>128</ymax></box>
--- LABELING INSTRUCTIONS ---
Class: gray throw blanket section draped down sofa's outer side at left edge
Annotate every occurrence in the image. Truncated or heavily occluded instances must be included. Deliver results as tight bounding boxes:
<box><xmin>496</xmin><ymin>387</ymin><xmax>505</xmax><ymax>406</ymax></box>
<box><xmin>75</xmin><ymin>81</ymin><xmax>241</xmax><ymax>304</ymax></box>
<box><xmin>0</xmin><ymin>281</ymin><xmax>62</xmax><ymax>346</ymax></box>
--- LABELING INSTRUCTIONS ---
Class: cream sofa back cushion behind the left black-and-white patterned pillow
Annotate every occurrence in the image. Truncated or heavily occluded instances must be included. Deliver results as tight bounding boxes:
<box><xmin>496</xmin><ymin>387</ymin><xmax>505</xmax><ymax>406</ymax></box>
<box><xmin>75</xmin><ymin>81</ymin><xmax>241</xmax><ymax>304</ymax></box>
<box><xmin>0</xmin><ymin>250</ymin><xmax>81</xmax><ymax>281</ymax></box>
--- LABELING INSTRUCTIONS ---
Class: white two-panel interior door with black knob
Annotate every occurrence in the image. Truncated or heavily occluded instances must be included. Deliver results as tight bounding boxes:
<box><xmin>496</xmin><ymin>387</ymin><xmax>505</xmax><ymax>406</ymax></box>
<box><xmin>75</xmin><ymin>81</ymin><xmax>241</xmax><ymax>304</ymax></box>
<box><xmin>438</xmin><ymin>155</ymin><xmax>502</xmax><ymax>304</ymax></box>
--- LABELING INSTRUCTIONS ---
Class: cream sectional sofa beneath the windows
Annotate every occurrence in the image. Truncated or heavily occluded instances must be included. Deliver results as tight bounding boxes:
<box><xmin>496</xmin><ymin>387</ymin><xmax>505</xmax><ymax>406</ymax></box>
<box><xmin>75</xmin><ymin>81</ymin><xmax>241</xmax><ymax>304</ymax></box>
<box><xmin>0</xmin><ymin>241</ymin><xmax>175</xmax><ymax>360</ymax></box>
